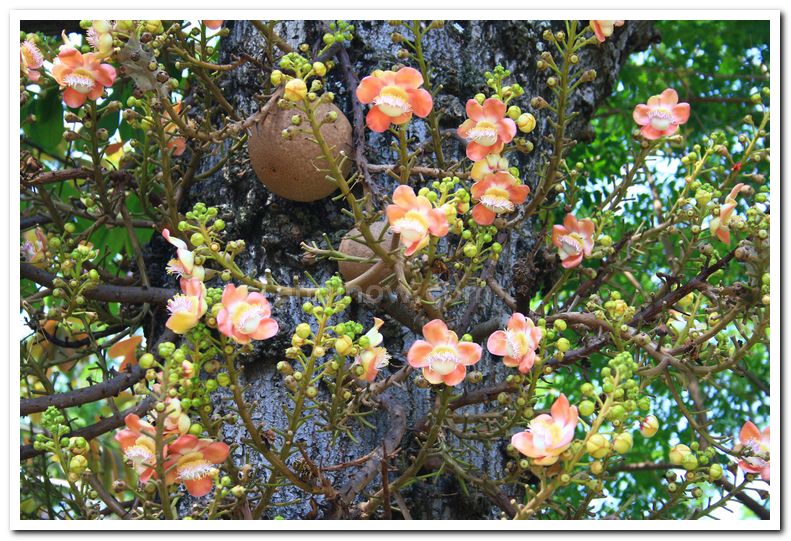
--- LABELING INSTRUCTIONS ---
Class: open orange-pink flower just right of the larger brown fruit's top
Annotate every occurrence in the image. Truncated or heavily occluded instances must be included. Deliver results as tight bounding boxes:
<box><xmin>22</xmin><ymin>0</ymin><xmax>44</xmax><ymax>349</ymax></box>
<box><xmin>357</xmin><ymin>68</ymin><xmax>434</xmax><ymax>133</ymax></box>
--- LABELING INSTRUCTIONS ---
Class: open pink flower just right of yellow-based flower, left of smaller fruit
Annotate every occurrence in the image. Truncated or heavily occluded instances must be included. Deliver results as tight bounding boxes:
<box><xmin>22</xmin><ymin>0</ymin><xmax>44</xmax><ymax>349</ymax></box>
<box><xmin>217</xmin><ymin>284</ymin><xmax>278</xmax><ymax>344</ymax></box>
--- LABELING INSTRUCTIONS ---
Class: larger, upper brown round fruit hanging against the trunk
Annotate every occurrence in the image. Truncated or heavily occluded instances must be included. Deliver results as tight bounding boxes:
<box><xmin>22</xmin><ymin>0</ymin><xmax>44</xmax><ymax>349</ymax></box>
<box><xmin>247</xmin><ymin>103</ymin><xmax>352</xmax><ymax>202</ymax></box>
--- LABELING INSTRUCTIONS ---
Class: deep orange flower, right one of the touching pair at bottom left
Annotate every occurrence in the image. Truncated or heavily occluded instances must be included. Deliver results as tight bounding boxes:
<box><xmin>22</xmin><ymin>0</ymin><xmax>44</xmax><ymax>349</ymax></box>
<box><xmin>165</xmin><ymin>434</ymin><xmax>231</xmax><ymax>498</ymax></box>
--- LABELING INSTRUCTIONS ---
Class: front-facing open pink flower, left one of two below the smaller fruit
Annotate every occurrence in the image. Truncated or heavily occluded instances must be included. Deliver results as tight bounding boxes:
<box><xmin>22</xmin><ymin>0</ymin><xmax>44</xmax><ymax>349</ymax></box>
<box><xmin>407</xmin><ymin>319</ymin><xmax>482</xmax><ymax>385</ymax></box>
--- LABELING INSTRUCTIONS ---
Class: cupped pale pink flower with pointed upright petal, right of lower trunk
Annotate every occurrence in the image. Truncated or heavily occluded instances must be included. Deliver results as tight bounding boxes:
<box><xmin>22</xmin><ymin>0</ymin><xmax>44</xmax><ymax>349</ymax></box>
<box><xmin>511</xmin><ymin>394</ymin><xmax>578</xmax><ymax>466</ymax></box>
